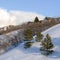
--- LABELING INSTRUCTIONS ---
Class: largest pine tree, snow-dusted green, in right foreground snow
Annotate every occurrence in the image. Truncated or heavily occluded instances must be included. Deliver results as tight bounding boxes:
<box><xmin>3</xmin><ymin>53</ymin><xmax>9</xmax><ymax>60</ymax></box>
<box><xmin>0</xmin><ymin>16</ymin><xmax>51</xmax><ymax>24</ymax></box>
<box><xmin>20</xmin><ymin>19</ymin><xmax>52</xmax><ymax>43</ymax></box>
<box><xmin>40</xmin><ymin>34</ymin><xmax>54</xmax><ymax>55</ymax></box>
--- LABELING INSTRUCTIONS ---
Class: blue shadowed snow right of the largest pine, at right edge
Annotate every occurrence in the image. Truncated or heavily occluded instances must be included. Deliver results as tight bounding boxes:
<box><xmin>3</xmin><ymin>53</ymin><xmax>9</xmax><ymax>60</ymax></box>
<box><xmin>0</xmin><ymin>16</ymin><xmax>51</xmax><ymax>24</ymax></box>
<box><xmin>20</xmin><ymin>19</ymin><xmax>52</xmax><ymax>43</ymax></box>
<box><xmin>49</xmin><ymin>38</ymin><xmax>60</xmax><ymax>58</ymax></box>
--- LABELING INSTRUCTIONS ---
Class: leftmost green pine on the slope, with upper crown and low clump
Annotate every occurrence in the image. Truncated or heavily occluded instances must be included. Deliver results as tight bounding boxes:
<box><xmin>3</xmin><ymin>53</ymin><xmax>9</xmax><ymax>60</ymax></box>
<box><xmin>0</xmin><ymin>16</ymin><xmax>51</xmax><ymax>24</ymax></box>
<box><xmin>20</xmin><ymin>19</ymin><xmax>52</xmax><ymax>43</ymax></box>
<box><xmin>24</xmin><ymin>29</ymin><xmax>33</xmax><ymax>48</ymax></box>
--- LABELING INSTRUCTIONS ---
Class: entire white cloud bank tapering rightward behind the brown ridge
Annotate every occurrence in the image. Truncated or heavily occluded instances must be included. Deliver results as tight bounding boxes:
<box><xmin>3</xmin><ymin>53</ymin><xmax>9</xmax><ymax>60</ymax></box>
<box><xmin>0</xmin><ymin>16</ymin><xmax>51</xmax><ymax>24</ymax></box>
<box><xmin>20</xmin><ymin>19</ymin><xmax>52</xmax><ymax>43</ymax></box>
<box><xmin>0</xmin><ymin>8</ymin><xmax>45</xmax><ymax>27</ymax></box>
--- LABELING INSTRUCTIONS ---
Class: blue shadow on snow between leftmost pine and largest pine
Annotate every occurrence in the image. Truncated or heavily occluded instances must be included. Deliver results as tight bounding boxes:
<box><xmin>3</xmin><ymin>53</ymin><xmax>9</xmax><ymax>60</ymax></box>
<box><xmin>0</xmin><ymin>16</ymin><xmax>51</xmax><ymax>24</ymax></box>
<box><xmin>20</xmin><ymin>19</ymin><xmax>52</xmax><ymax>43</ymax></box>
<box><xmin>17</xmin><ymin>43</ymin><xmax>40</xmax><ymax>55</ymax></box>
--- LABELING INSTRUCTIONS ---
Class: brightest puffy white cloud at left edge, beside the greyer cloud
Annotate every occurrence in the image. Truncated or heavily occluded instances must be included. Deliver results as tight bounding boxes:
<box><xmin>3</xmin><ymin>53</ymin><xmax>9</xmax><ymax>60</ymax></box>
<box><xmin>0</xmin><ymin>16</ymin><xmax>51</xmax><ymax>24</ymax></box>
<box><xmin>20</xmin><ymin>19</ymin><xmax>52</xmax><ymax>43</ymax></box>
<box><xmin>0</xmin><ymin>8</ymin><xmax>10</xmax><ymax>26</ymax></box>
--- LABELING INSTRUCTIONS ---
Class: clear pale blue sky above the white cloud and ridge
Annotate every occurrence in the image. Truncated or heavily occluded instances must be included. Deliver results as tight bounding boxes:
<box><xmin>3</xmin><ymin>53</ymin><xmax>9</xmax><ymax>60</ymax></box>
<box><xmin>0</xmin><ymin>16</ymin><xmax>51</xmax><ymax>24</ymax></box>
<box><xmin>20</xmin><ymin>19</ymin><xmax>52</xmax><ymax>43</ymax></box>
<box><xmin>0</xmin><ymin>0</ymin><xmax>60</xmax><ymax>17</ymax></box>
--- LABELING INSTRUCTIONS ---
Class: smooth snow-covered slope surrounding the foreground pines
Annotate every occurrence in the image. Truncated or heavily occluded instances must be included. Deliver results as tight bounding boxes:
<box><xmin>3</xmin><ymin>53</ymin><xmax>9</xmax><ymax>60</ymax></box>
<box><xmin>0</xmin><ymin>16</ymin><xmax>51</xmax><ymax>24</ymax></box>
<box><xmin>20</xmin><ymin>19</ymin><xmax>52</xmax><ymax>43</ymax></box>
<box><xmin>0</xmin><ymin>24</ymin><xmax>60</xmax><ymax>60</ymax></box>
